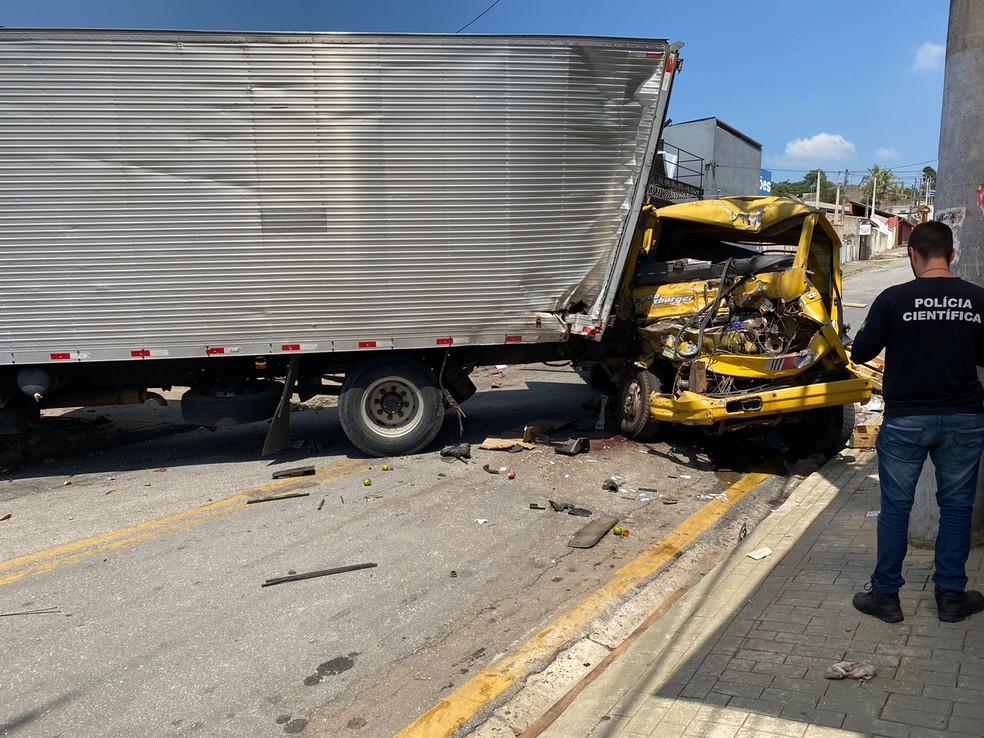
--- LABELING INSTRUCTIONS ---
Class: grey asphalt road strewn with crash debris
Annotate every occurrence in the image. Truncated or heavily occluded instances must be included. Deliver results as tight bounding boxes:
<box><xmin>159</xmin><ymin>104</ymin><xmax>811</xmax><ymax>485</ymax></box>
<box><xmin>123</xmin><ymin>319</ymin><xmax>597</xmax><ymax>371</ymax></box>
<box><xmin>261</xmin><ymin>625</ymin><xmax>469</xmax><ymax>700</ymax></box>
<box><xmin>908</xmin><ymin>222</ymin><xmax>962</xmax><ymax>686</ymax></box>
<box><xmin>0</xmin><ymin>254</ymin><xmax>908</xmax><ymax>738</ymax></box>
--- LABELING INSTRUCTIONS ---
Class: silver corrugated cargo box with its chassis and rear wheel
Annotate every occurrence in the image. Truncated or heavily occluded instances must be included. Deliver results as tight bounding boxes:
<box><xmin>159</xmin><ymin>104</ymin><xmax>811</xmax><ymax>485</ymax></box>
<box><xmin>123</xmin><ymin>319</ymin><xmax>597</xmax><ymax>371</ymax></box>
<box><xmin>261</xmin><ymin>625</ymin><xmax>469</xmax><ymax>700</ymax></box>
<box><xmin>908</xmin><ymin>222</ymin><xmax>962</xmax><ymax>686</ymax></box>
<box><xmin>0</xmin><ymin>29</ymin><xmax>680</xmax><ymax>455</ymax></box>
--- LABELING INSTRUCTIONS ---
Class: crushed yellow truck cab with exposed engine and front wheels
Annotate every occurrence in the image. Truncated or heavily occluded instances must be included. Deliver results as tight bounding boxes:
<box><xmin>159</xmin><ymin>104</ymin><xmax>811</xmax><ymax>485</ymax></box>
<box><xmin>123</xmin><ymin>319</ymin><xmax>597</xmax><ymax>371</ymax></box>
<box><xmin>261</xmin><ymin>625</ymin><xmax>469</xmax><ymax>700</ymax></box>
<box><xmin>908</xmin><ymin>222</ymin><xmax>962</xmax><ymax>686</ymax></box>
<box><xmin>616</xmin><ymin>197</ymin><xmax>871</xmax><ymax>453</ymax></box>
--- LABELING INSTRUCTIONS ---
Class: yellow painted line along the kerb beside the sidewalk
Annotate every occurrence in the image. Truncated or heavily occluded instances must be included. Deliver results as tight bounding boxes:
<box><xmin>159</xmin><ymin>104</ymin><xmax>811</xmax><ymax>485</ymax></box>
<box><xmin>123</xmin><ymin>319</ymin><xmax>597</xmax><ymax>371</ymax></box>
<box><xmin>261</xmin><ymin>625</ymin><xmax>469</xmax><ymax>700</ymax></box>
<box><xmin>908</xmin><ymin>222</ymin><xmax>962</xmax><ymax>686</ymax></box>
<box><xmin>395</xmin><ymin>473</ymin><xmax>772</xmax><ymax>738</ymax></box>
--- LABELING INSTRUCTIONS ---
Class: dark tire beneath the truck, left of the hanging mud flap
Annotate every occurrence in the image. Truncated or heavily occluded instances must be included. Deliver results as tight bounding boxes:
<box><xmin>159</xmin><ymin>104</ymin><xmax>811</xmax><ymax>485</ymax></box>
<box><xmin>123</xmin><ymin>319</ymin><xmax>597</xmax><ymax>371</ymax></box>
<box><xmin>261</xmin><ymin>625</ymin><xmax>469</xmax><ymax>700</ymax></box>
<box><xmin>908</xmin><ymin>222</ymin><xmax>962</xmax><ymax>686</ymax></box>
<box><xmin>181</xmin><ymin>380</ymin><xmax>284</xmax><ymax>426</ymax></box>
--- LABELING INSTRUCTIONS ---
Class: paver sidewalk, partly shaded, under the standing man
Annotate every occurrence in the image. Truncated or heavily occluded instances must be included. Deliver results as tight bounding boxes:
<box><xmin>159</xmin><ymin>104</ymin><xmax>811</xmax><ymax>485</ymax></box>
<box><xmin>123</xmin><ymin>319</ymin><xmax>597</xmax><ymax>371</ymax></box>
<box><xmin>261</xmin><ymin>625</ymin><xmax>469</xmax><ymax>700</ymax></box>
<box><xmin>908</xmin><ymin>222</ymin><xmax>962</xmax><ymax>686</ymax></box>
<box><xmin>542</xmin><ymin>451</ymin><xmax>984</xmax><ymax>738</ymax></box>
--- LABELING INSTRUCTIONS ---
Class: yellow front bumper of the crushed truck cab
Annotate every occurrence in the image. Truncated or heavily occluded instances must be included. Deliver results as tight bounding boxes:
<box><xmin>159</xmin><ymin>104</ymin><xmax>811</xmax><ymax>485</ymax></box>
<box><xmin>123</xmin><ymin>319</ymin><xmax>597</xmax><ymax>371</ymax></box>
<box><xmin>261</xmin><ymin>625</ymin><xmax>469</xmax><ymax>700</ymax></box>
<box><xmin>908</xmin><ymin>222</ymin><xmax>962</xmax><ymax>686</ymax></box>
<box><xmin>649</xmin><ymin>377</ymin><xmax>871</xmax><ymax>426</ymax></box>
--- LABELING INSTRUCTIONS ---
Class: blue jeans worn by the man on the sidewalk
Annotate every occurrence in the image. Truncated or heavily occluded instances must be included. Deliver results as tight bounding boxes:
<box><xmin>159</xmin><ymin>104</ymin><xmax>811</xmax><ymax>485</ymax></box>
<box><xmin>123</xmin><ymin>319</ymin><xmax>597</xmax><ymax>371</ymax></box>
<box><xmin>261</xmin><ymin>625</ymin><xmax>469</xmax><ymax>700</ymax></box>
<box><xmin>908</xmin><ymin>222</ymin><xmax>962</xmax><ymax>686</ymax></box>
<box><xmin>871</xmin><ymin>414</ymin><xmax>984</xmax><ymax>594</ymax></box>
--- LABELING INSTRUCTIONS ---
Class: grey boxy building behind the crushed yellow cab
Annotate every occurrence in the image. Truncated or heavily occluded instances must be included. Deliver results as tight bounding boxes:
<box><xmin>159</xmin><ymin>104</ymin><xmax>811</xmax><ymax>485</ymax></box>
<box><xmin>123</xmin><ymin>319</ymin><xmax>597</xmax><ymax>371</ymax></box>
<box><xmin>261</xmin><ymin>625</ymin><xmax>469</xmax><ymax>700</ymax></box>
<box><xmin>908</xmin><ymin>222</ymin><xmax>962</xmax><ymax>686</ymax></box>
<box><xmin>663</xmin><ymin>118</ymin><xmax>764</xmax><ymax>198</ymax></box>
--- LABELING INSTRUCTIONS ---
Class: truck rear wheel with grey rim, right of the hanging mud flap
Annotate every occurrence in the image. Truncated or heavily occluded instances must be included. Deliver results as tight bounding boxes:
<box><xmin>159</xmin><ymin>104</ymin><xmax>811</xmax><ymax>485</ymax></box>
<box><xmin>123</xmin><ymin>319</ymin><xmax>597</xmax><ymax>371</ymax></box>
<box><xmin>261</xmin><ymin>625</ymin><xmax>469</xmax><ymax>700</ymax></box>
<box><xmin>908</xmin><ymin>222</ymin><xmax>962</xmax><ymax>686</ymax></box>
<box><xmin>338</xmin><ymin>357</ymin><xmax>444</xmax><ymax>456</ymax></box>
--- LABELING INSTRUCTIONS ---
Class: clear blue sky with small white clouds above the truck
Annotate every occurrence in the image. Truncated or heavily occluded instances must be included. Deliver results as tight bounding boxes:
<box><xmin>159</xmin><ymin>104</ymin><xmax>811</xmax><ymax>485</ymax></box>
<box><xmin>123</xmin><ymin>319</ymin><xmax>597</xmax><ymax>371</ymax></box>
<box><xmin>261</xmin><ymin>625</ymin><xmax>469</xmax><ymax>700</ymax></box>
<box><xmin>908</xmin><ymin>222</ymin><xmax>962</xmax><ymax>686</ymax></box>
<box><xmin>0</xmin><ymin>0</ymin><xmax>949</xmax><ymax>184</ymax></box>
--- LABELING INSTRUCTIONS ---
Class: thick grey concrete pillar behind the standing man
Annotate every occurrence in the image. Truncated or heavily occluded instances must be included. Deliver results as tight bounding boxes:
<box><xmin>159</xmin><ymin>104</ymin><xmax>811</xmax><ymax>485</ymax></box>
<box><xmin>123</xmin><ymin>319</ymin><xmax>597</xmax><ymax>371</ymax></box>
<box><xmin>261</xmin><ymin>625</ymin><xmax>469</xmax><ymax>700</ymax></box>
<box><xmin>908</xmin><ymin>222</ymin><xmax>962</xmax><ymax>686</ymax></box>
<box><xmin>909</xmin><ymin>0</ymin><xmax>984</xmax><ymax>546</ymax></box>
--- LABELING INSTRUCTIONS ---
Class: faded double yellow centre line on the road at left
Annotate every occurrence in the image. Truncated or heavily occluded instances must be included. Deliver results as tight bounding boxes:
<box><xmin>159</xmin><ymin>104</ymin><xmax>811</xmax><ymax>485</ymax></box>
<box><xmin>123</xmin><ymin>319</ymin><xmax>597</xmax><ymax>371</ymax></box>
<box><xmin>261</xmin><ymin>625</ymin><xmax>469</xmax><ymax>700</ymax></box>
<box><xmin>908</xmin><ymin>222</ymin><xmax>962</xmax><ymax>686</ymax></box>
<box><xmin>0</xmin><ymin>459</ymin><xmax>366</xmax><ymax>586</ymax></box>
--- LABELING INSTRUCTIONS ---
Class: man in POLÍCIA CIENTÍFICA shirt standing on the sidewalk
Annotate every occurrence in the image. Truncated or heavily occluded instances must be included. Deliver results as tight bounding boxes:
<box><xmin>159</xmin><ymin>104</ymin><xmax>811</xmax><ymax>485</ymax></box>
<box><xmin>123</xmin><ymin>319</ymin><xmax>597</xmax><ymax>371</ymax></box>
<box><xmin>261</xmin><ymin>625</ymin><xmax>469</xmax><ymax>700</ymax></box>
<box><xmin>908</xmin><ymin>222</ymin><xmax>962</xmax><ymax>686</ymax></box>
<box><xmin>851</xmin><ymin>221</ymin><xmax>984</xmax><ymax>623</ymax></box>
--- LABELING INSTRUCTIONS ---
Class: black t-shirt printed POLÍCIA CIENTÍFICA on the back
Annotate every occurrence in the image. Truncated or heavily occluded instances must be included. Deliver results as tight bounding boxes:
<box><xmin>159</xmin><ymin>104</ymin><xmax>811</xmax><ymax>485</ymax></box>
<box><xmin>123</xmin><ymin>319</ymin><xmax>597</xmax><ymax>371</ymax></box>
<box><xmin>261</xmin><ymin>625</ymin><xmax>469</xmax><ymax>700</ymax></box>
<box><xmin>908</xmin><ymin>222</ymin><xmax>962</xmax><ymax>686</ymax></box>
<box><xmin>851</xmin><ymin>277</ymin><xmax>984</xmax><ymax>417</ymax></box>
